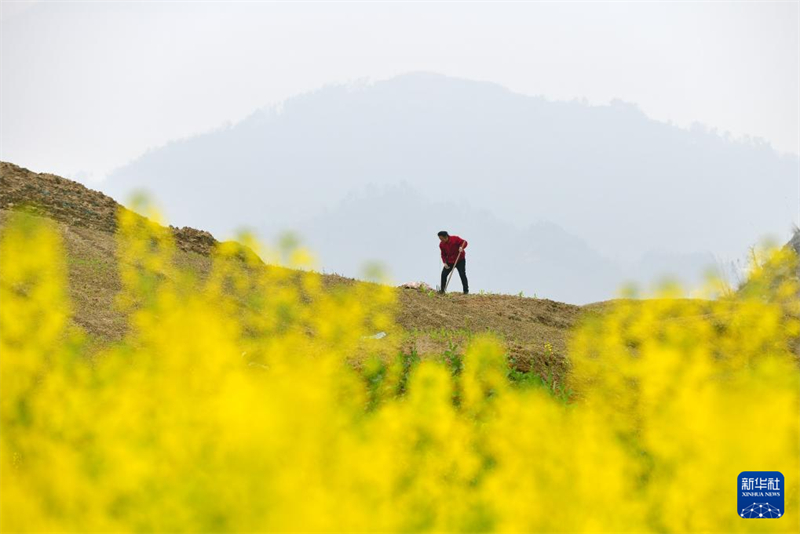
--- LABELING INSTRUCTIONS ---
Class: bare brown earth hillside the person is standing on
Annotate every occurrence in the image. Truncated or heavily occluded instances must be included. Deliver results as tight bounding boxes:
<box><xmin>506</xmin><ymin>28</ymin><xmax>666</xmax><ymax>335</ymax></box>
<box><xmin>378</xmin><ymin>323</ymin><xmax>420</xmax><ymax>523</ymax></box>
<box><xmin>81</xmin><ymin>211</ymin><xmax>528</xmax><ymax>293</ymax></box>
<box><xmin>0</xmin><ymin>162</ymin><xmax>581</xmax><ymax>376</ymax></box>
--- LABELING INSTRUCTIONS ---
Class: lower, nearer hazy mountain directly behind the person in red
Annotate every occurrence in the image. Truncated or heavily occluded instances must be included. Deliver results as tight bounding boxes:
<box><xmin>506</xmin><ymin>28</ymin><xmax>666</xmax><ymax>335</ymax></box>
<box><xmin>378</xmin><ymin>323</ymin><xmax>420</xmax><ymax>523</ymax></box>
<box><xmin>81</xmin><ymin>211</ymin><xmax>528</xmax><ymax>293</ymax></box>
<box><xmin>288</xmin><ymin>183</ymin><xmax>714</xmax><ymax>304</ymax></box>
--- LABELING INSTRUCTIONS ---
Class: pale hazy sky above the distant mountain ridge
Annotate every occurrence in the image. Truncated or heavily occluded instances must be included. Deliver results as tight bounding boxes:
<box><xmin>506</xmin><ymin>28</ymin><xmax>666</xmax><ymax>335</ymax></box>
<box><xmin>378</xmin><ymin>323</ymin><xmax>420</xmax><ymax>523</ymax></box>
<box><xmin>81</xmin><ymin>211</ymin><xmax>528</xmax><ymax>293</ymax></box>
<box><xmin>0</xmin><ymin>0</ymin><xmax>800</xmax><ymax>181</ymax></box>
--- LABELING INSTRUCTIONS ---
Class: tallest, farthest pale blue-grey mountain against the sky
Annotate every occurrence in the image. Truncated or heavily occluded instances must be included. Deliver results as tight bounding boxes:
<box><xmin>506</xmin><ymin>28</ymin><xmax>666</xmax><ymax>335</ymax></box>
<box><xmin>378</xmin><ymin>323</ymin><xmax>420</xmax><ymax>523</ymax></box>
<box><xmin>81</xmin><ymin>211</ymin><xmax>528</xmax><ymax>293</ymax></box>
<box><xmin>104</xmin><ymin>73</ymin><xmax>800</xmax><ymax>300</ymax></box>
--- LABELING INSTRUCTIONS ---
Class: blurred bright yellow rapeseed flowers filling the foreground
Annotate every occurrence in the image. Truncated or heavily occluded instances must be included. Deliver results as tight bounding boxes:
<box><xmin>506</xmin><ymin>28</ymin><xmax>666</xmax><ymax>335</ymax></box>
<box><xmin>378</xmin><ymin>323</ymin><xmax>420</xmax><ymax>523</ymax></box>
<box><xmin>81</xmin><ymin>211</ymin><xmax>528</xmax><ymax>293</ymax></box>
<box><xmin>0</xmin><ymin>212</ymin><xmax>800</xmax><ymax>532</ymax></box>
